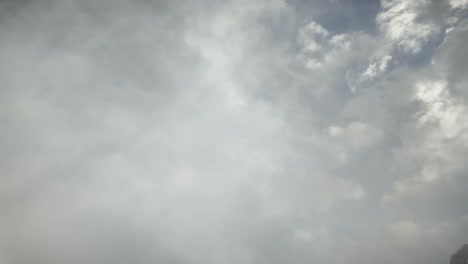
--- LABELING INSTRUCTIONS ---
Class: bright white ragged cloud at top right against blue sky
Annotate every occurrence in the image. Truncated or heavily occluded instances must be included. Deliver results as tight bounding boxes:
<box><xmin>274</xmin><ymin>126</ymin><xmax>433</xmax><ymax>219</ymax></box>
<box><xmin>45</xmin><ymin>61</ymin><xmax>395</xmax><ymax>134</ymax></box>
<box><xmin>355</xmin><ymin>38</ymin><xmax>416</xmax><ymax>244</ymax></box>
<box><xmin>346</xmin><ymin>0</ymin><xmax>464</xmax><ymax>92</ymax></box>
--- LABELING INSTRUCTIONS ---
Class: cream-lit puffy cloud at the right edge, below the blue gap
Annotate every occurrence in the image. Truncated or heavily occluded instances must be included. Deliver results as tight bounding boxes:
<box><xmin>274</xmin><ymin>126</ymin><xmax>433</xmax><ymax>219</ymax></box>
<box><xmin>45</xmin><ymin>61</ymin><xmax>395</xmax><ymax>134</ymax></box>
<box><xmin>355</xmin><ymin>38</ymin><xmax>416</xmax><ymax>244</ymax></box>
<box><xmin>385</xmin><ymin>81</ymin><xmax>468</xmax><ymax>203</ymax></box>
